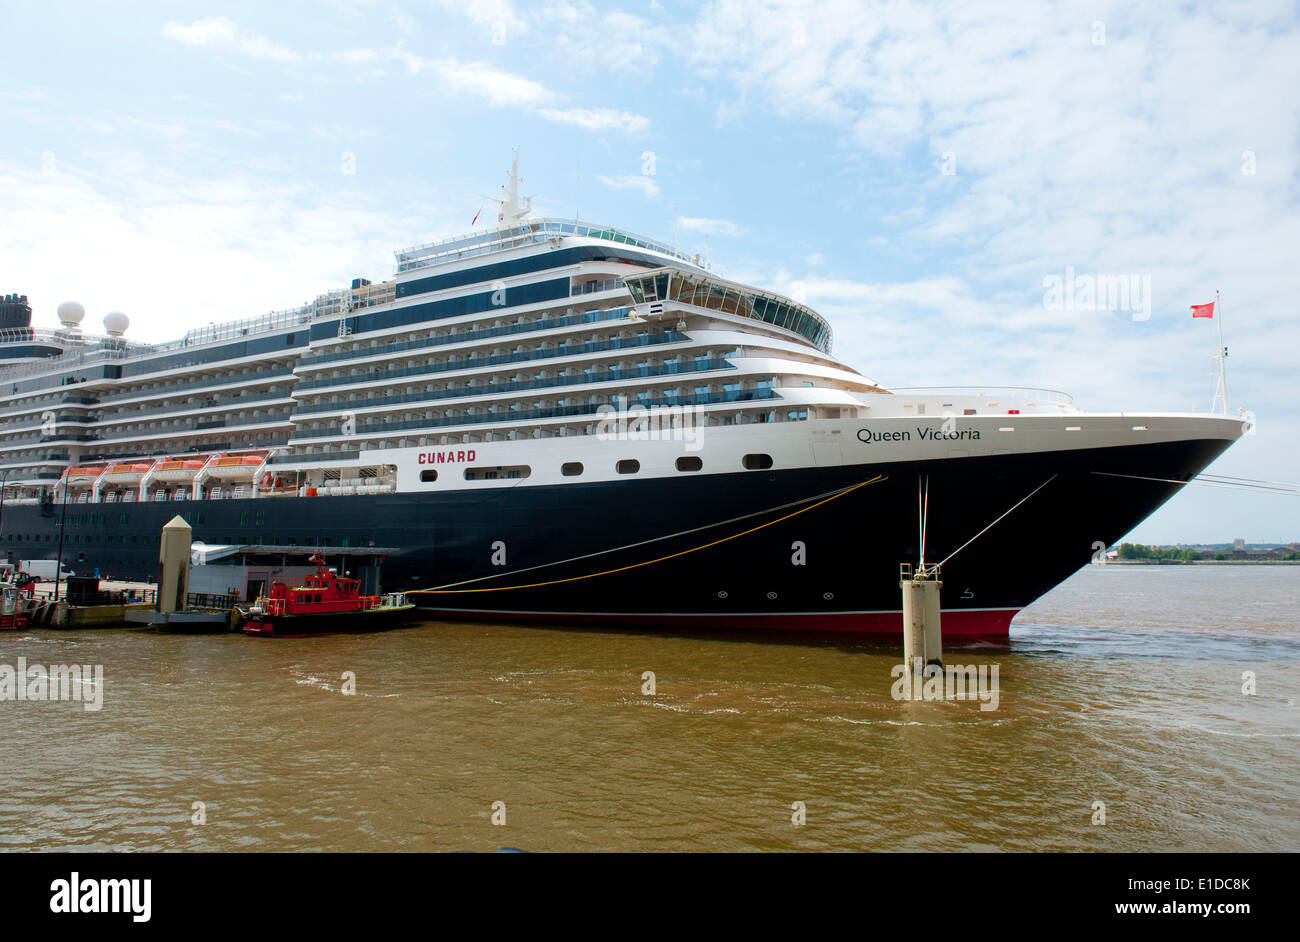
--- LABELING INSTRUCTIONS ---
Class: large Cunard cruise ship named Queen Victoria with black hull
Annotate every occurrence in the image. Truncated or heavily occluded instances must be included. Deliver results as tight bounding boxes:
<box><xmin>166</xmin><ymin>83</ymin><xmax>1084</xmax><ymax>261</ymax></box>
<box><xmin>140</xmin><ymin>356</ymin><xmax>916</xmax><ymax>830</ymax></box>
<box><xmin>0</xmin><ymin>159</ymin><xmax>1243</xmax><ymax>637</ymax></box>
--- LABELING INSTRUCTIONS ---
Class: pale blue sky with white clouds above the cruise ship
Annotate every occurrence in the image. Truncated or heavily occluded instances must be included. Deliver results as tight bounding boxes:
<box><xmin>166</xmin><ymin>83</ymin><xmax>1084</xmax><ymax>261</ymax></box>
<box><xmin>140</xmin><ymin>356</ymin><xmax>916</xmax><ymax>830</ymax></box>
<box><xmin>0</xmin><ymin>0</ymin><xmax>1300</xmax><ymax>543</ymax></box>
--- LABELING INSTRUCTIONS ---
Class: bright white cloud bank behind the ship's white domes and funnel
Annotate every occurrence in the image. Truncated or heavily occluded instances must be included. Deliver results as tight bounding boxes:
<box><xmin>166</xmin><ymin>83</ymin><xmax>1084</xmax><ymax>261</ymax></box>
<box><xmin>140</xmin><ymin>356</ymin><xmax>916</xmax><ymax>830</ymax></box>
<box><xmin>0</xmin><ymin>161</ymin><xmax>437</xmax><ymax>342</ymax></box>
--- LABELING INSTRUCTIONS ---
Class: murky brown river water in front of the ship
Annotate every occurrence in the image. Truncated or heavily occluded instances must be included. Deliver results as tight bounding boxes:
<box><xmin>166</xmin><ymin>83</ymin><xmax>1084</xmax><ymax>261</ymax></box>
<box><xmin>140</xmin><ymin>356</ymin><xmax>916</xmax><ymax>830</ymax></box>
<box><xmin>0</xmin><ymin>565</ymin><xmax>1300</xmax><ymax>851</ymax></box>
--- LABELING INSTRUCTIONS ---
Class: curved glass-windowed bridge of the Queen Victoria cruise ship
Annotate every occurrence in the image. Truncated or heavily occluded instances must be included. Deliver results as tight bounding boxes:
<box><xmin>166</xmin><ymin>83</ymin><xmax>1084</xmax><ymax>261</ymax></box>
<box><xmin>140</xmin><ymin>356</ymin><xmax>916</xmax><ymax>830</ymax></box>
<box><xmin>623</xmin><ymin>268</ymin><xmax>831</xmax><ymax>353</ymax></box>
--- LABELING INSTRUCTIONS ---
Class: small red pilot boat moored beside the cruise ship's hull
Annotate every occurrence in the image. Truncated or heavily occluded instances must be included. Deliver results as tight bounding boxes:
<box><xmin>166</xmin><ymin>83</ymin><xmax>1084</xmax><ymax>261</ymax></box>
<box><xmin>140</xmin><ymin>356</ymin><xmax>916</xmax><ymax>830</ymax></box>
<box><xmin>243</xmin><ymin>556</ymin><xmax>415</xmax><ymax>638</ymax></box>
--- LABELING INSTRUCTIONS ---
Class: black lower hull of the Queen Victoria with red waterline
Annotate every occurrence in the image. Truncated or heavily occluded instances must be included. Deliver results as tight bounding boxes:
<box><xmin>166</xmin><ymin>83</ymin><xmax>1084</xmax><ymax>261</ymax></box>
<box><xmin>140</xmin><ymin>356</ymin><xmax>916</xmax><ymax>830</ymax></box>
<box><xmin>0</xmin><ymin>439</ymin><xmax>1230</xmax><ymax>634</ymax></box>
